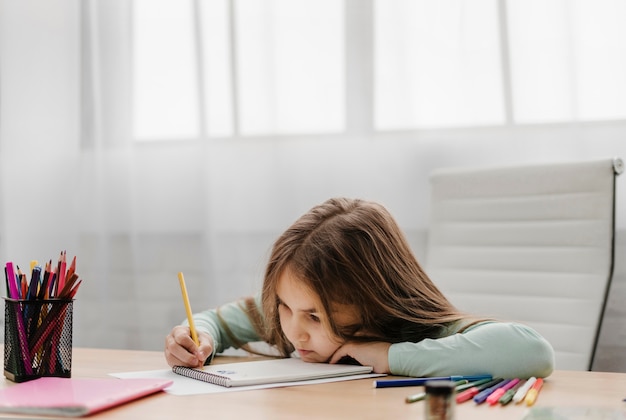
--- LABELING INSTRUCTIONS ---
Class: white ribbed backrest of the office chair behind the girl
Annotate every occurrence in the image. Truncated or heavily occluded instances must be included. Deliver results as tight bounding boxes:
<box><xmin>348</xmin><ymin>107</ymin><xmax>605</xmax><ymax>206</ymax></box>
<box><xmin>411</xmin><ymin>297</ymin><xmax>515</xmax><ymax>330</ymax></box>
<box><xmin>425</xmin><ymin>158</ymin><xmax>624</xmax><ymax>370</ymax></box>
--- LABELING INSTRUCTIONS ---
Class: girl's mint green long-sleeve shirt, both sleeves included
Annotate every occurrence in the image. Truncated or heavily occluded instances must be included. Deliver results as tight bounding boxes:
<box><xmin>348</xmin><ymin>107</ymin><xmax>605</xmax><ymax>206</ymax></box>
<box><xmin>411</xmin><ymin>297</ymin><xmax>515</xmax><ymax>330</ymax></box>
<box><xmin>188</xmin><ymin>296</ymin><xmax>554</xmax><ymax>378</ymax></box>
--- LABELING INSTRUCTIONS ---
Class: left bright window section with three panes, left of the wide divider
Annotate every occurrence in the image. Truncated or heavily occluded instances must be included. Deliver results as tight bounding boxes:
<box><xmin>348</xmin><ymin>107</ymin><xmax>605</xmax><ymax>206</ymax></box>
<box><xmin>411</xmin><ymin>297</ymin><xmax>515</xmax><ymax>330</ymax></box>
<box><xmin>133</xmin><ymin>0</ymin><xmax>345</xmax><ymax>139</ymax></box>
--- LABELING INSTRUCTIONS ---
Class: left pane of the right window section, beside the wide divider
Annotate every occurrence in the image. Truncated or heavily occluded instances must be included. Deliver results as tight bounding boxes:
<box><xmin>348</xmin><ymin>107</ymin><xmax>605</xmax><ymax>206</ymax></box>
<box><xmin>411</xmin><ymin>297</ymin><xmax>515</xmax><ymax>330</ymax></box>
<box><xmin>374</xmin><ymin>0</ymin><xmax>505</xmax><ymax>130</ymax></box>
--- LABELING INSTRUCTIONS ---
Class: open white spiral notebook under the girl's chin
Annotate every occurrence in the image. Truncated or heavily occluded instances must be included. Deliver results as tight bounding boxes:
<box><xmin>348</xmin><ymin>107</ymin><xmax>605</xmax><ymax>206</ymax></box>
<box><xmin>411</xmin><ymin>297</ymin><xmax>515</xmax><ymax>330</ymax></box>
<box><xmin>172</xmin><ymin>358</ymin><xmax>372</xmax><ymax>387</ymax></box>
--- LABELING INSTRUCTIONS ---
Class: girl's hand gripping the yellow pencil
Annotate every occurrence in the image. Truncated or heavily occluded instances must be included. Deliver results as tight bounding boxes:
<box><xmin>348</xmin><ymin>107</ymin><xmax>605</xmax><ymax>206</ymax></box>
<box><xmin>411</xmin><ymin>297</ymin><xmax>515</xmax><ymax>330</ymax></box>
<box><xmin>165</xmin><ymin>325</ymin><xmax>213</xmax><ymax>367</ymax></box>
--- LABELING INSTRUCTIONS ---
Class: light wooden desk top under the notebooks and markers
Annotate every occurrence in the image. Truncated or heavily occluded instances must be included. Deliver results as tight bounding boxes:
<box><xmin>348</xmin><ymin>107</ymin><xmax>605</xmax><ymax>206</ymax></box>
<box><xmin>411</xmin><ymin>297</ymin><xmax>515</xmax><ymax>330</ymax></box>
<box><xmin>0</xmin><ymin>348</ymin><xmax>626</xmax><ymax>420</ymax></box>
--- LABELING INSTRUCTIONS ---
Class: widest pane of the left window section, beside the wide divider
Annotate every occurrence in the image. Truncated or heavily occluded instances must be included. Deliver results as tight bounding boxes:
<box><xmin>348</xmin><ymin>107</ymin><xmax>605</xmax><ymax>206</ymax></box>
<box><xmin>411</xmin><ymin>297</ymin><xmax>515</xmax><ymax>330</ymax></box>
<box><xmin>235</xmin><ymin>0</ymin><xmax>345</xmax><ymax>135</ymax></box>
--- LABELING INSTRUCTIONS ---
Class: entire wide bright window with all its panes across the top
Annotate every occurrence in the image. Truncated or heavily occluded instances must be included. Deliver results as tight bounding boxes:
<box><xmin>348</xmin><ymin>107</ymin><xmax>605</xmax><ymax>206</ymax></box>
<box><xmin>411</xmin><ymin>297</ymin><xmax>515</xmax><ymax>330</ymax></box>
<box><xmin>132</xmin><ymin>0</ymin><xmax>626</xmax><ymax>140</ymax></box>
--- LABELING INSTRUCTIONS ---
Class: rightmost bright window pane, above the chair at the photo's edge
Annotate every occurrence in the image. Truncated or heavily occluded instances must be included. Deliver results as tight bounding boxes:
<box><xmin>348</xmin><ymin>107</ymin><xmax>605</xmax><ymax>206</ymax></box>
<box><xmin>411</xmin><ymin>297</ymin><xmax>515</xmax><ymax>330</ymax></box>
<box><xmin>507</xmin><ymin>0</ymin><xmax>626</xmax><ymax>123</ymax></box>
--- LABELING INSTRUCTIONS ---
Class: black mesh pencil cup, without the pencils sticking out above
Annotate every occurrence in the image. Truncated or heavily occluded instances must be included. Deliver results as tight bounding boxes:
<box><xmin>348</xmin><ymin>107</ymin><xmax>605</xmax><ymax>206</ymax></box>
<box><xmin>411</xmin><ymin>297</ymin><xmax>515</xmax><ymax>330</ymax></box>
<box><xmin>4</xmin><ymin>298</ymin><xmax>73</xmax><ymax>382</ymax></box>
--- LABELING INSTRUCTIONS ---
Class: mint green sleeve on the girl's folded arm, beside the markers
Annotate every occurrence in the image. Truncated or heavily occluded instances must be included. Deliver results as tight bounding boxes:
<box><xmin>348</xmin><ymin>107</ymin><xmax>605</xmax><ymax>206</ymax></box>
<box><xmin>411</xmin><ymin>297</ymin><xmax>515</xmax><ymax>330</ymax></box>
<box><xmin>389</xmin><ymin>321</ymin><xmax>554</xmax><ymax>378</ymax></box>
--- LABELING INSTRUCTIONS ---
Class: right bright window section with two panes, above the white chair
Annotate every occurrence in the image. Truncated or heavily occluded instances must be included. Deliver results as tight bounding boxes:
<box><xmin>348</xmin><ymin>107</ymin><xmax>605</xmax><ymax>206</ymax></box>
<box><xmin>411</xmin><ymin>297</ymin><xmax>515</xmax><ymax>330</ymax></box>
<box><xmin>375</xmin><ymin>0</ymin><xmax>626</xmax><ymax>130</ymax></box>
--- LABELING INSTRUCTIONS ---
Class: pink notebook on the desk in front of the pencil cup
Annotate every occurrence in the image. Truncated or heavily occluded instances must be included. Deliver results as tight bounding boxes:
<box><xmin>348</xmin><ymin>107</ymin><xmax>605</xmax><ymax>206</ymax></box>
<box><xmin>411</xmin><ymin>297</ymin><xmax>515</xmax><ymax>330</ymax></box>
<box><xmin>0</xmin><ymin>377</ymin><xmax>172</xmax><ymax>417</ymax></box>
